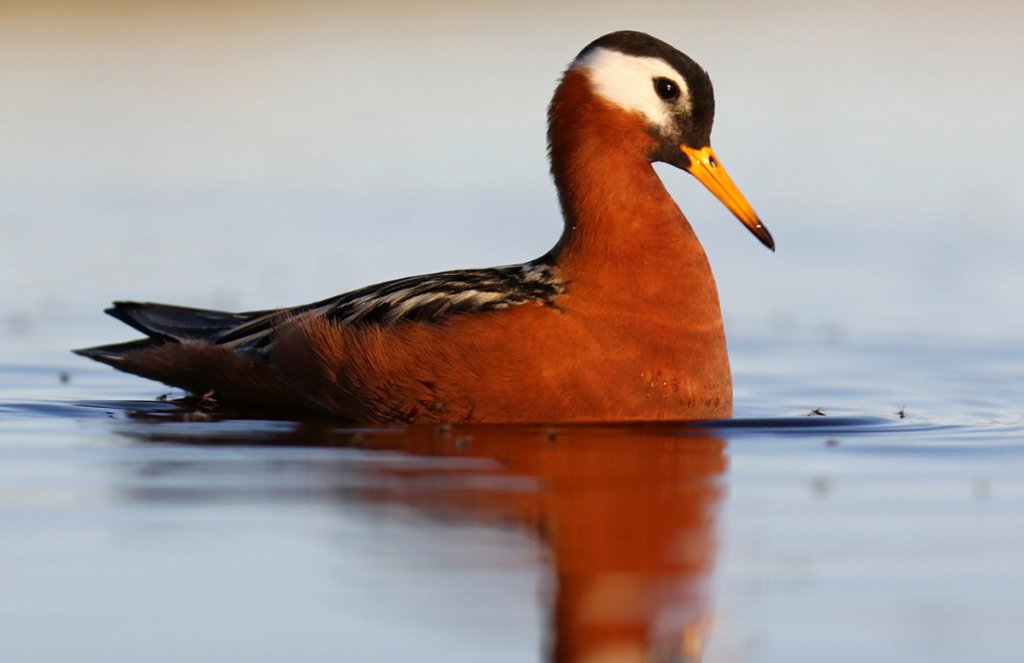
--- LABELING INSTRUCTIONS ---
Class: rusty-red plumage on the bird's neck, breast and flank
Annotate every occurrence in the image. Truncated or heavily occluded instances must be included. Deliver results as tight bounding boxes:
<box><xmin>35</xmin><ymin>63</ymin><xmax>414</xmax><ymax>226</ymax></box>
<box><xmin>81</xmin><ymin>33</ymin><xmax>761</xmax><ymax>422</ymax></box>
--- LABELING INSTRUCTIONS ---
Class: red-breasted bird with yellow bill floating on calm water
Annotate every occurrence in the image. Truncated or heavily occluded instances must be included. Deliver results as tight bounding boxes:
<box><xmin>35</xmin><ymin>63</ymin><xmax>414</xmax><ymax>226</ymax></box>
<box><xmin>74</xmin><ymin>31</ymin><xmax>775</xmax><ymax>424</ymax></box>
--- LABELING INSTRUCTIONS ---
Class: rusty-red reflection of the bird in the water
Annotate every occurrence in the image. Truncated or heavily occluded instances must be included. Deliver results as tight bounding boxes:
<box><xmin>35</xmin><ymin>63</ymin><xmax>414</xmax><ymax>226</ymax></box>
<box><xmin>116</xmin><ymin>412</ymin><xmax>727</xmax><ymax>662</ymax></box>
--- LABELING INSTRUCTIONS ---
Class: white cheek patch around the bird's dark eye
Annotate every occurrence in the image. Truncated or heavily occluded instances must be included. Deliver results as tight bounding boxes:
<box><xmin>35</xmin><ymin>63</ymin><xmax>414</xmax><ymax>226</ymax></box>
<box><xmin>570</xmin><ymin>48</ymin><xmax>692</xmax><ymax>131</ymax></box>
